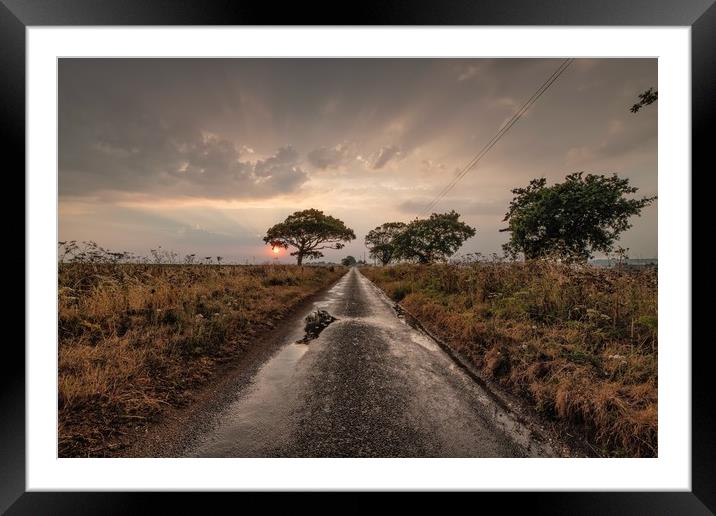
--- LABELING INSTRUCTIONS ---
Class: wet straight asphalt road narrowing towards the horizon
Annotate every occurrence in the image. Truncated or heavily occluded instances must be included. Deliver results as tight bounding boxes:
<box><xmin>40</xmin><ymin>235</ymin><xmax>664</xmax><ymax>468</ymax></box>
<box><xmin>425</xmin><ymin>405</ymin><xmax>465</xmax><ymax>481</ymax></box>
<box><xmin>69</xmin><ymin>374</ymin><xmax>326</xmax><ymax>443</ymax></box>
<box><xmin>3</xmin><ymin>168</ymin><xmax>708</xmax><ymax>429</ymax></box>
<box><xmin>186</xmin><ymin>268</ymin><xmax>550</xmax><ymax>457</ymax></box>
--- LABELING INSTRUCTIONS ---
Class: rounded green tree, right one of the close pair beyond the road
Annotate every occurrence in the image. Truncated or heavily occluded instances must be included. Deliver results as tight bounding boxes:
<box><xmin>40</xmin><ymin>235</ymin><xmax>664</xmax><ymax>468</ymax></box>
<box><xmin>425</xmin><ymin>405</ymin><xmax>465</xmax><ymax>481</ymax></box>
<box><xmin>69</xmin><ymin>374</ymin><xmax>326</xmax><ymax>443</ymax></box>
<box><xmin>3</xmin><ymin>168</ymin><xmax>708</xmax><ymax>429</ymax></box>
<box><xmin>393</xmin><ymin>211</ymin><xmax>476</xmax><ymax>263</ymax></box>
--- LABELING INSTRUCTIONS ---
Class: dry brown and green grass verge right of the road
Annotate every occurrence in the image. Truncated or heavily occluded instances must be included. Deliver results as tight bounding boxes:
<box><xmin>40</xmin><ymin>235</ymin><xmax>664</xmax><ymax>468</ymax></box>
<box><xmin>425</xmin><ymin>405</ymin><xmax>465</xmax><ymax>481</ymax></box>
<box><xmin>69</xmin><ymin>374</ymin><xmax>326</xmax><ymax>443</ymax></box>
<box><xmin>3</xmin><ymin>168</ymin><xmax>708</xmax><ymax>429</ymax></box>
<box><xmin>362</xmin><ymin>262</ymin><xmax>657</xmax><ymax>457</ymax></box>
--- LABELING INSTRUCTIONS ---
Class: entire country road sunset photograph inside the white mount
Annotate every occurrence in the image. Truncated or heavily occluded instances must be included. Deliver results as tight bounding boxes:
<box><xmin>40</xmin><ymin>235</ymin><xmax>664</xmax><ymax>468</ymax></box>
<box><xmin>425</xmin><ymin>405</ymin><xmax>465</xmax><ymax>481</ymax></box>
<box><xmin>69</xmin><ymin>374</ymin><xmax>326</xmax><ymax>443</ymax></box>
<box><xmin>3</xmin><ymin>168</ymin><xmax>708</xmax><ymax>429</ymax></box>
<box><xmin>56</xmin><ymin>57</ymin><xmax>668</xmax><ymax>458</ymax></box>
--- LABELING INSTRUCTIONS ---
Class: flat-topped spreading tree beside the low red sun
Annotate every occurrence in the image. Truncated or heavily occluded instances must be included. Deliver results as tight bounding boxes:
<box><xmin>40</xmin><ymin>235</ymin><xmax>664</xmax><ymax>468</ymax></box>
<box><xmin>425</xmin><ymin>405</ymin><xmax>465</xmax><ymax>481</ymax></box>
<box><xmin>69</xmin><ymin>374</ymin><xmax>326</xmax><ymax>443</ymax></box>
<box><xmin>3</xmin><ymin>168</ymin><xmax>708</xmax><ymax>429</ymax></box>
<box><xmin>264</xmin><ymin>209</ymin><xmax>356</xmax><ymax>265</ymax></box>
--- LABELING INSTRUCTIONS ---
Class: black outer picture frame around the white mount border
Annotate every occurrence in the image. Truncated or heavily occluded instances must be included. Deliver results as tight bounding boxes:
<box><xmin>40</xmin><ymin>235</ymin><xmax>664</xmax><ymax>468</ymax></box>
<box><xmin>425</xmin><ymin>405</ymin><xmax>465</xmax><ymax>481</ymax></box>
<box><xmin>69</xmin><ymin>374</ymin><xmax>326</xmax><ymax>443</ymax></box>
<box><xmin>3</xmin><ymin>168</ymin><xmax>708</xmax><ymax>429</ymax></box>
<box><xmin>0</xmin><ymin>0</ymin><xmax>716</xmax><ymax>514</ymax></box>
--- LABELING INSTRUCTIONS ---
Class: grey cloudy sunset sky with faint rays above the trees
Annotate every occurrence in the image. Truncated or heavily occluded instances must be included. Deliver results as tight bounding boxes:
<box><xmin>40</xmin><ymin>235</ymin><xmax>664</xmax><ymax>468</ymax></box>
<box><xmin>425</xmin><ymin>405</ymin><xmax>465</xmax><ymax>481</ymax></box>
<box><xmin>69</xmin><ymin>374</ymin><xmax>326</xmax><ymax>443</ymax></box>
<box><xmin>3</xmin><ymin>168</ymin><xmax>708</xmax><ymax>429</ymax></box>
<box><xmin>58</xmin><ymin>58</ymin><xmax>658</xmax><ymax>263</ymax></box>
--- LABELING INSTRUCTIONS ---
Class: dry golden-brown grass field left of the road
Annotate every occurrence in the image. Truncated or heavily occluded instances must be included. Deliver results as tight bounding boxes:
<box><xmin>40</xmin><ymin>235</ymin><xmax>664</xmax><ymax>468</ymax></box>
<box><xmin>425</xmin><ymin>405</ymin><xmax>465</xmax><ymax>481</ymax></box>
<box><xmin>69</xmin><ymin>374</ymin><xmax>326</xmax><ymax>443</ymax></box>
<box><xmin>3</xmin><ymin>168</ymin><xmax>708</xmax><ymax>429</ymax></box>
<box><xmin>58</xmin><ymin>263</ymin><xmax>345</xmax><ymax>457</ymax></box>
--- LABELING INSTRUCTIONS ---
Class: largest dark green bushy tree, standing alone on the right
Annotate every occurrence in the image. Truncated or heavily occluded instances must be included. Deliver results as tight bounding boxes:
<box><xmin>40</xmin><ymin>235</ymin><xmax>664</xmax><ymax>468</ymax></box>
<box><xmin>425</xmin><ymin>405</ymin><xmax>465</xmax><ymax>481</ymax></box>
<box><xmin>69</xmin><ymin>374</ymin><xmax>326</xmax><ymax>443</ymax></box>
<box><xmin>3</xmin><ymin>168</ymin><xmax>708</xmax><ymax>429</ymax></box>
<box><xmin>500</xmin><ymin>172</ymin><xmax>656</xmax><ymax>261</ymax></box>
